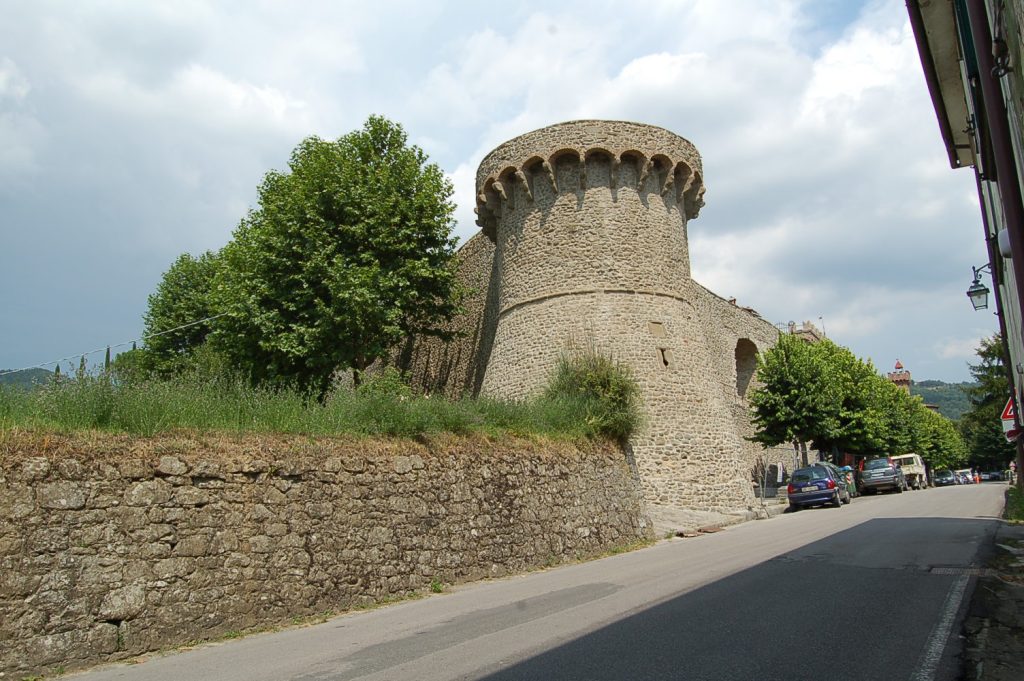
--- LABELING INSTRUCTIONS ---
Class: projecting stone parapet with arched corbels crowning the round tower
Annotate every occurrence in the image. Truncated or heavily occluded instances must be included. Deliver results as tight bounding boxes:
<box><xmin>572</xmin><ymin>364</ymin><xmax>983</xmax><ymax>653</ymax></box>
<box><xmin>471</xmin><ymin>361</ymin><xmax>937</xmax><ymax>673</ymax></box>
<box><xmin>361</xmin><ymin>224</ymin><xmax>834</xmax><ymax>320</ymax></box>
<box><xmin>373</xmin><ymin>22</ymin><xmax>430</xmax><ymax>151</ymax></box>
<box><xmin>476</xmin><ymin>121</ymin><xmax>705</xmax><ymax>241</ymax></box>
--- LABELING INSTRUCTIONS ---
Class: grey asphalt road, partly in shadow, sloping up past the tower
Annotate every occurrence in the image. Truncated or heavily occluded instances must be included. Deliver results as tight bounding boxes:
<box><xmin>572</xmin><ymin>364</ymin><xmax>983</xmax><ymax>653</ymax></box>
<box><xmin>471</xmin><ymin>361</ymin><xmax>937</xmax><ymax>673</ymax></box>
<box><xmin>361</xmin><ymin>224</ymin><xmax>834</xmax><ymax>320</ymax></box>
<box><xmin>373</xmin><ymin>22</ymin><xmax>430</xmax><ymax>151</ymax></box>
<box><xmin>73</xmin><ymin>483</ymin><xmax>1006</xmax><ymax>681</ymax></box>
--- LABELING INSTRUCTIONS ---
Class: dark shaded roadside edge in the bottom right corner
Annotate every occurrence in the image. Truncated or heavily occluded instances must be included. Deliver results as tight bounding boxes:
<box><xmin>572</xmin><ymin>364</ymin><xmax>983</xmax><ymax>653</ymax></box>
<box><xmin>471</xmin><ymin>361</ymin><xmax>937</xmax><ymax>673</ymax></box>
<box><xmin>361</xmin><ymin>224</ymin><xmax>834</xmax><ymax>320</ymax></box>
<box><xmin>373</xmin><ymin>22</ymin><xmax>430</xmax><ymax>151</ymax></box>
<box><xmin>964</xmin><ymin>522</ymin><xmax>1024</xmax><ymax>681</ymax></box>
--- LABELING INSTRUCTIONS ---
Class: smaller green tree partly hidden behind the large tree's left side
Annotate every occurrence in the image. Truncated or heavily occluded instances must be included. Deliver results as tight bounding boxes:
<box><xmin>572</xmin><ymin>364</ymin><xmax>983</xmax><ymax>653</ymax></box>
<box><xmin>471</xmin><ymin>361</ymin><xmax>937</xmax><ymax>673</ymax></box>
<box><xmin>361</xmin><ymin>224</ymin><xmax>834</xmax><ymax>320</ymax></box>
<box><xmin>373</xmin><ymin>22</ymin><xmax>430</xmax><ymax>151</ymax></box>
<box><xmin>139</xmin><ymin>251</ymin><xmax>219</xmax><ymax>375</ymax></box>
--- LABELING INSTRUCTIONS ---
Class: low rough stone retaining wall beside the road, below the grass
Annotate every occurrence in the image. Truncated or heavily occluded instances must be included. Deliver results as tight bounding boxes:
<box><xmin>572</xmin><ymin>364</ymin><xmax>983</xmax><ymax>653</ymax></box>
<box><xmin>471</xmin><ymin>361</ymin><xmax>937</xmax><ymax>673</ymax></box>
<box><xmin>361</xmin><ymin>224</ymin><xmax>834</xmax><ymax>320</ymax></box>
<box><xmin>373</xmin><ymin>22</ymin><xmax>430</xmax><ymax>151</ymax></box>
<box><xmin>0</xmin><ymin>434</ymin><xmax>650</xmax><ymax>677</ymax></box>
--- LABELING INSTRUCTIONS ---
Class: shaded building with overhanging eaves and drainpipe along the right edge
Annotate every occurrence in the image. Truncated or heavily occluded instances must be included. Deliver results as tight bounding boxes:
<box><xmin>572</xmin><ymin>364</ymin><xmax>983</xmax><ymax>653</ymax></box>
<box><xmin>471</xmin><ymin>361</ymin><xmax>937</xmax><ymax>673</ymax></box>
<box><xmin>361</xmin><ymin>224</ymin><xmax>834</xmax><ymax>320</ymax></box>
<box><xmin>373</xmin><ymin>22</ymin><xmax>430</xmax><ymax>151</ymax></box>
<box><xmin>906</xmin><ymin>0</ymin><xmax>1024</xmax><ymax>483</ymax></box>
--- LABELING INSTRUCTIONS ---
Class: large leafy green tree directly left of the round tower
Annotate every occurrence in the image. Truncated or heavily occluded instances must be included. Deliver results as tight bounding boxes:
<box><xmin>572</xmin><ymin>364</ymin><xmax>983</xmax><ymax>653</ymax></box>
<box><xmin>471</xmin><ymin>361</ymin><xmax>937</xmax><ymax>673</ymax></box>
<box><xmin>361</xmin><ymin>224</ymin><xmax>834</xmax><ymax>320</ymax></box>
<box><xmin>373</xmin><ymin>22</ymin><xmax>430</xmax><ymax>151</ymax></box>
<box><xmin>215</xmin><ymin>116</ymin><xmax>458</xmax><ymax>395</ymax></box>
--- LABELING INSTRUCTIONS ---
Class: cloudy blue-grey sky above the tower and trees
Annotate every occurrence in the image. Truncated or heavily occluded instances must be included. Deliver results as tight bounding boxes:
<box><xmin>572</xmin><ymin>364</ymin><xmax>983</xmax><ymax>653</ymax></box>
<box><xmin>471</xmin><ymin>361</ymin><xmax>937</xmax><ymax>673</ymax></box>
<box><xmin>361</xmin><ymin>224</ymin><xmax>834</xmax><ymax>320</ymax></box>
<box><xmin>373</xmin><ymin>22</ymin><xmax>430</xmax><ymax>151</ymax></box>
<box><xmin>0</xmin><ymin>0</ymin><xmax>996</xmax><ymax>381</ymax></box>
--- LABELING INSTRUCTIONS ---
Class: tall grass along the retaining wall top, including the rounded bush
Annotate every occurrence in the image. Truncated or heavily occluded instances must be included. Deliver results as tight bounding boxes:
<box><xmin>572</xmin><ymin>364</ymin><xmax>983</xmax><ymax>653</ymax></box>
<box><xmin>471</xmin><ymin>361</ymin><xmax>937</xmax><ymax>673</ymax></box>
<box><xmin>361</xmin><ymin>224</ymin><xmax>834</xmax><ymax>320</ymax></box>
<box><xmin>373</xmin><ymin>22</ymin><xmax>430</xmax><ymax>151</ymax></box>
<box><xmin>0</xmin><ymin>350</ymin><xmax>637</xmax><ymax>439</ymax></box>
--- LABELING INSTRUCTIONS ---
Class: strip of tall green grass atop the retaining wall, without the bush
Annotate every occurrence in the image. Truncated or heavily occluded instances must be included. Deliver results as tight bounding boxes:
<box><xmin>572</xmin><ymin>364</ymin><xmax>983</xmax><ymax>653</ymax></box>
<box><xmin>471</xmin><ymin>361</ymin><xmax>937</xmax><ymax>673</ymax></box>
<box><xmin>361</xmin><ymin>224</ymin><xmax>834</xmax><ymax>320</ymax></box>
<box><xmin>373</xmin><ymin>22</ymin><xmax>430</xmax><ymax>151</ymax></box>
<box><xmin>0</xmin><ymin>376</ymin><xmax>601</xmax><ymax>439</ymax></box>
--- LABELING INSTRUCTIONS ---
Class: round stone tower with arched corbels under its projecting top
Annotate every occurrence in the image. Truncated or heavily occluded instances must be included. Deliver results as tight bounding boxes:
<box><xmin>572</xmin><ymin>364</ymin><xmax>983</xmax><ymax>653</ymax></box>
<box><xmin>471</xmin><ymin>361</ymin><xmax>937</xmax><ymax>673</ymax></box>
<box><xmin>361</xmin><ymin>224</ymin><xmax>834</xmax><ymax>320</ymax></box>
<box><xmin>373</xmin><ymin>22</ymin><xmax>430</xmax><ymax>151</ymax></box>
<box><xmin>476</xmin><ymin>121</ymin><xmax>751</xmax><ymax>509</ymax></box>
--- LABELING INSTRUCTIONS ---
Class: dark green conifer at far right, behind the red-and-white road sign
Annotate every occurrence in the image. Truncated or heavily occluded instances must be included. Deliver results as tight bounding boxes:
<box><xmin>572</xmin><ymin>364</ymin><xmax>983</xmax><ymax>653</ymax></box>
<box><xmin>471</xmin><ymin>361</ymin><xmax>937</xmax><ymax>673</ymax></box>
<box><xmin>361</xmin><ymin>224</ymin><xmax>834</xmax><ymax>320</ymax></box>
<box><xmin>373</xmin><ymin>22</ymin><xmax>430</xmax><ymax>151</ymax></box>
<box><xmin>961</xmin><ymin>334</ymin><xmax>1016</xmax><ymax>470</ymax></box>
